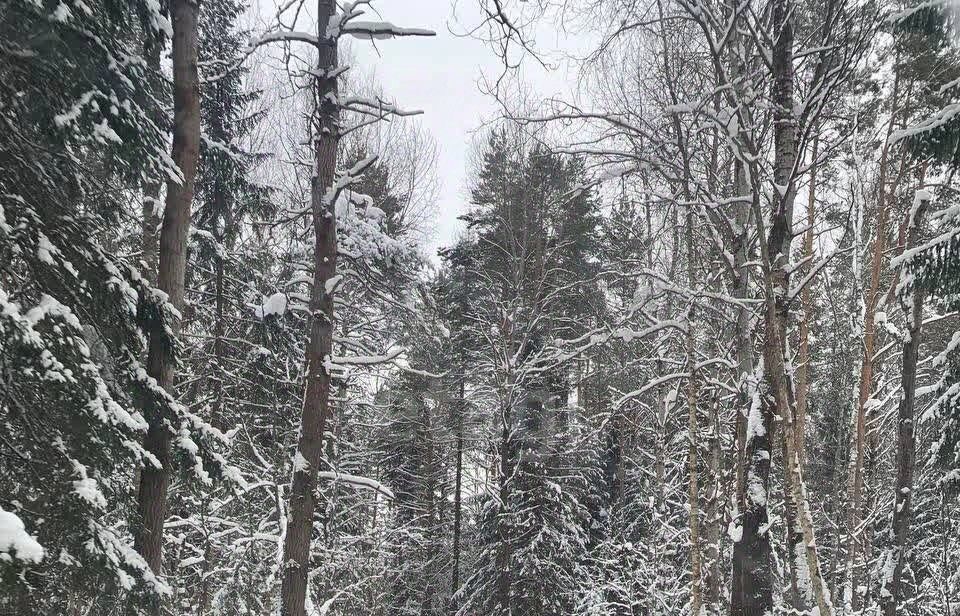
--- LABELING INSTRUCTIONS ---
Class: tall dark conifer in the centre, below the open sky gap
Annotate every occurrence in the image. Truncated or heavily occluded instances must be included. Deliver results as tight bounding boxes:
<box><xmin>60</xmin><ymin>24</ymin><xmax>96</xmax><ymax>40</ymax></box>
<box><xmin>445</xmin><ymin>131</ymin><xmax>597</xmax><ymax>615</ymax></box>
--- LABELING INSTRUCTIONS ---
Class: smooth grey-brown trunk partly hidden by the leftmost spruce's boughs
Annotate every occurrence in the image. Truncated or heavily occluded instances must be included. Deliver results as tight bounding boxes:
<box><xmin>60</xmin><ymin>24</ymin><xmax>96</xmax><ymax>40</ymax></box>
<box><xmin>136</xmin><ymin>0</ymin><xmax>200</xmax><ymax>575</ymax></box>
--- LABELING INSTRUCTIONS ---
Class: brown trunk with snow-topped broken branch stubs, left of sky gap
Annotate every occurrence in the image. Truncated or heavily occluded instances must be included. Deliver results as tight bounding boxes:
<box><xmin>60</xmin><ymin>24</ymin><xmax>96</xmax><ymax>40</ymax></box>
<box><xmin>280</xmin><ymin>0</ymin><xmax>340</xmax><ymax>616</ymax></box>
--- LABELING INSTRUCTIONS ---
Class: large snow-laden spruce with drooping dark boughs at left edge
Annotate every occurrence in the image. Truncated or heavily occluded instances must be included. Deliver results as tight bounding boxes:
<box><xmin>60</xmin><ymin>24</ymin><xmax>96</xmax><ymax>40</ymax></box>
<box><xmin>0</xmin><ymin>1</ymin><xmax>182</xmax><ymax>613</ymax></box>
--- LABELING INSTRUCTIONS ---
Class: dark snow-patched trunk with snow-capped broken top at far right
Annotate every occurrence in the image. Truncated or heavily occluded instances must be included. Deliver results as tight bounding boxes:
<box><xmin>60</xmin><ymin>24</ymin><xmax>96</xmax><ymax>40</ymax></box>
<box><xmin>880</xmin><ymin>188</ymin><xmax>926</xmax><ymax>616</ymax></box>
